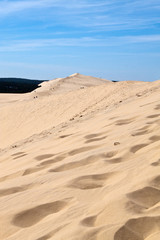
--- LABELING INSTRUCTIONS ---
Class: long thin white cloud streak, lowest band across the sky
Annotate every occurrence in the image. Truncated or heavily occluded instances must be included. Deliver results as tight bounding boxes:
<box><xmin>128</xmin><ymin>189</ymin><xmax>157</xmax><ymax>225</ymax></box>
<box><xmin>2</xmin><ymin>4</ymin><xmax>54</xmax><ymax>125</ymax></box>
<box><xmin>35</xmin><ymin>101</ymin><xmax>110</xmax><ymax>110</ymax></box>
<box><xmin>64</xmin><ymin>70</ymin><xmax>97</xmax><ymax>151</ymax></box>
<box><xmin>0</xmin><ymin>35</ymin><xmax>160</xmax><ymax>52</ymax></box>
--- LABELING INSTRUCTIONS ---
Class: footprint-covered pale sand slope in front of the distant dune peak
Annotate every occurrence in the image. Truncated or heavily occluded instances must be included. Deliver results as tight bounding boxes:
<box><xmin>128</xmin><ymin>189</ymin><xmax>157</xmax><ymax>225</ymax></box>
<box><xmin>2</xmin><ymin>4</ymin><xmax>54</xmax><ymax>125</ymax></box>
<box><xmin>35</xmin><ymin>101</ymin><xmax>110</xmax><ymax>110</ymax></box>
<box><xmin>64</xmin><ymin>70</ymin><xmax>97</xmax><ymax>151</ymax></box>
<box><xmin>0</xmin><ymin>74</ymin><xmax>160</xmax><ymax>240</ymax></box>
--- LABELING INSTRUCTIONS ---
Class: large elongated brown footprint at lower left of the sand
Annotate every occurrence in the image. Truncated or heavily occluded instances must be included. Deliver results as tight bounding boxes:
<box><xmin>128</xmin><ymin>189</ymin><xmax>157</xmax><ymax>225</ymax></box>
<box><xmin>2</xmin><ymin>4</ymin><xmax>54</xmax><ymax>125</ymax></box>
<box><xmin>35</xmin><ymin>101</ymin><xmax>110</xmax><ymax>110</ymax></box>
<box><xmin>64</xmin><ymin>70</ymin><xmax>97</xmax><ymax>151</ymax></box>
<box><xmin>12</xmin><ymin>200</ymin><xmax>69</xmax><ymax>228</ymax></box>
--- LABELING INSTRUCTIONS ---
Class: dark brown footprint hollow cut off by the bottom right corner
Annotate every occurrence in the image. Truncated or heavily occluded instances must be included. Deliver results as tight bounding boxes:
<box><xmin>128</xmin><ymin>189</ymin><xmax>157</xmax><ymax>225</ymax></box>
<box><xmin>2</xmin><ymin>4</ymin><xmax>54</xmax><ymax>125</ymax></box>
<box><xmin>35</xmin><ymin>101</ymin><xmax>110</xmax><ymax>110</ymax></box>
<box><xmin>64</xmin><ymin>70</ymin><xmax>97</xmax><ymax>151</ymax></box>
<box><xmin>114</xmin><ymin>216</ymin><xmax>160</xmax><ymax>240</ymax></box>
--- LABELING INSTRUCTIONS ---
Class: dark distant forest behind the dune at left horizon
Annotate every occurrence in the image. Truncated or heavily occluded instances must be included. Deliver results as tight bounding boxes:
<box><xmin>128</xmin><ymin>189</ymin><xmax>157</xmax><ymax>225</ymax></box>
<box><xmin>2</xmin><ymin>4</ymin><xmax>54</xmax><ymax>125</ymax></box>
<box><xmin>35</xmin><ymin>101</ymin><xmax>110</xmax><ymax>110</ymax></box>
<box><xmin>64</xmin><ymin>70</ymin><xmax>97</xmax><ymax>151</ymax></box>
<box><xmin>0</xmin><ymin>78</ymin><xmax>47</xmax><ymax>93</ymax></box>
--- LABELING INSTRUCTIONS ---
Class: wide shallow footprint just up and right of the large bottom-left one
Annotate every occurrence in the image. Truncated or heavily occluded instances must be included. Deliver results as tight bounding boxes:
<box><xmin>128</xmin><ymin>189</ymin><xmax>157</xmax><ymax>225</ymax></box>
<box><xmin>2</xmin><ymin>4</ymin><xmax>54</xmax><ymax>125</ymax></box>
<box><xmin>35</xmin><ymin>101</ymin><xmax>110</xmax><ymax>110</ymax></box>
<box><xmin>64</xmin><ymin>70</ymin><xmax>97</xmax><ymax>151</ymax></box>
<box><xmin>67</xmin><ymin>172</ymin><xmax>118</xmax><ymax>190</ymax></box>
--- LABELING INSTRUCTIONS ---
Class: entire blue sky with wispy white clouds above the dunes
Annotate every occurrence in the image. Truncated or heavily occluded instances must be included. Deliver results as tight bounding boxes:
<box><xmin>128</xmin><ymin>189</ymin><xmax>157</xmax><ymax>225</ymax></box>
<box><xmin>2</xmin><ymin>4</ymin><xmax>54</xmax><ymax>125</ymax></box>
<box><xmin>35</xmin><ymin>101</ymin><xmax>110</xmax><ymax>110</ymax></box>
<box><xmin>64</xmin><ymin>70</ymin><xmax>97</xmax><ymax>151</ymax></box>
<box><xmin>0</xmin><ymin>0</ymin><xmax>160</xmax><ymax>81</ymax></box>
